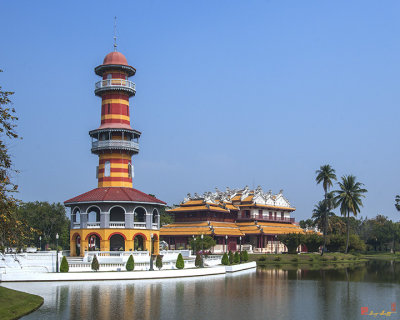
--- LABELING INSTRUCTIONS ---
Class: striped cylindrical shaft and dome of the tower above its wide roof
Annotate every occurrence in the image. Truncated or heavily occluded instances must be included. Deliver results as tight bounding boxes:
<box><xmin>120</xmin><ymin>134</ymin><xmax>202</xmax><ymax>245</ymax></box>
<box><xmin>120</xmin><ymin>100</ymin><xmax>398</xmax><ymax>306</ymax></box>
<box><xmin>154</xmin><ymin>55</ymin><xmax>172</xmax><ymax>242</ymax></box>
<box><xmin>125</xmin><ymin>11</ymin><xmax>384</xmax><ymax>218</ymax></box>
<box><xmin>89</xmin><ymin>51</ymin><xmax>140</xmax><ymax>188</ymax></box>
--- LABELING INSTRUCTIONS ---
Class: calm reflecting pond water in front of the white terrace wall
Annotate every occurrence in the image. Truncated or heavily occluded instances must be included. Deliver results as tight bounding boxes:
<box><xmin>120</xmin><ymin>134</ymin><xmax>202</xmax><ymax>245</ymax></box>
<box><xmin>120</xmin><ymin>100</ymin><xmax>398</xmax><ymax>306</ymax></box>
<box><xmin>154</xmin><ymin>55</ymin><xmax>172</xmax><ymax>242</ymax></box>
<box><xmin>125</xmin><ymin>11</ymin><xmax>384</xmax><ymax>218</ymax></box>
<box><xmin>3</xmin><ymin>261</ymin><xmax>400</xmax><ymax>320</ymax></box>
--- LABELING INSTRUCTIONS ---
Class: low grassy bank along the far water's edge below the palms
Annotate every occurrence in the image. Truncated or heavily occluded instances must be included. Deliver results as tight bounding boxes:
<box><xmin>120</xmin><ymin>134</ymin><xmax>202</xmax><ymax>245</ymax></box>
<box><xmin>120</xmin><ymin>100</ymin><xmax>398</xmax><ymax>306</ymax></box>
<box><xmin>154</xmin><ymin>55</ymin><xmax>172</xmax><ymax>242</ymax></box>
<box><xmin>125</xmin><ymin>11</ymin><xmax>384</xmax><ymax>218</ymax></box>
<box><xmin>249</xmin><ymin>253</ymin><xmax>368</xmax><ymax>267</ymax></box>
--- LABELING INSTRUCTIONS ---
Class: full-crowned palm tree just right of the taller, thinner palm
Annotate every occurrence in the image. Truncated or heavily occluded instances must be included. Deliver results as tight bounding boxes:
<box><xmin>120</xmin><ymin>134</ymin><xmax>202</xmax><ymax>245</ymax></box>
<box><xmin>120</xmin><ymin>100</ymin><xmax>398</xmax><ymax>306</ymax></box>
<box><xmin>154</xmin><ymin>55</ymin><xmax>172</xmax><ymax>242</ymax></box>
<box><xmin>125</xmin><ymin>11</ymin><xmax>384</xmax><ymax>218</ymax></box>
<box><xmin>334</xmin><ymin>175</ymin><xmax>368</xmax><ymax>253</ymax></box>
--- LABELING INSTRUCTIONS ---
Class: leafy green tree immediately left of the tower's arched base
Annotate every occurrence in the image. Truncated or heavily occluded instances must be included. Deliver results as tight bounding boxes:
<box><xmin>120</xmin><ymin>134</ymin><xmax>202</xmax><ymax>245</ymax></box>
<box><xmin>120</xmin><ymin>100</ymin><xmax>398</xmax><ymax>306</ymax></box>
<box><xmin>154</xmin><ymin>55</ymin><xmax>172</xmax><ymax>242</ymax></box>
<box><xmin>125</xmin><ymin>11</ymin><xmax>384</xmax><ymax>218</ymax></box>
<box><xmin>17</xmin><ymin>201</ymin><xmax>71</xmax><ymax>249</ymax></box>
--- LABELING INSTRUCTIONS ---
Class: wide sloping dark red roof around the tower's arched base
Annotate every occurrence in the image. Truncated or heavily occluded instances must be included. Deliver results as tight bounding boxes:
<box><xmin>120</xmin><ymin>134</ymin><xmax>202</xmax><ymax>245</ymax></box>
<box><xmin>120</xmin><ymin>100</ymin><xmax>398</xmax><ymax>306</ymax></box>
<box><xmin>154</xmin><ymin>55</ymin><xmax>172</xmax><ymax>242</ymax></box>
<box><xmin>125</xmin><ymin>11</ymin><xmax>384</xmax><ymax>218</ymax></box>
<box><xmin>64</xmin><ymin>187</ymin><xmax>166</xmax><ymax>204</ymax></box>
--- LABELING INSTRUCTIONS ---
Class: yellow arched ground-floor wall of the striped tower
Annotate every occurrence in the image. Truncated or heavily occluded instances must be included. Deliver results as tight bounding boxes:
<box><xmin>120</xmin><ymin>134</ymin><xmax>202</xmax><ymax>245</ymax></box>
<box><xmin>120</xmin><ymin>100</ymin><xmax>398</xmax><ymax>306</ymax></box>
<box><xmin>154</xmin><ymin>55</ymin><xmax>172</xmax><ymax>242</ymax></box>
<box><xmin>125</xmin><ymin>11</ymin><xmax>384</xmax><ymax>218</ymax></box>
<box><xmin>70</xmin><ymin>229</ymin><xmax>160</xmax><ymax>256</ymax></box>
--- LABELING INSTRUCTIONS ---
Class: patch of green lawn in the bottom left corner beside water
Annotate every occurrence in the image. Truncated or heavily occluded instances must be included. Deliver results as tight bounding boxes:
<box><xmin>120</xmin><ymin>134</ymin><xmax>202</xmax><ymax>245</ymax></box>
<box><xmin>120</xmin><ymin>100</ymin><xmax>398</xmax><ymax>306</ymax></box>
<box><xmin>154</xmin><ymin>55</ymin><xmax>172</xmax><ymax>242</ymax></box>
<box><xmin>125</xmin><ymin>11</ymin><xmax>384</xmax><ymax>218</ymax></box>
<box><xmin>0</xmin><ymin>286</ymin><xmax>43</xmax><ymax>319</ymax></box>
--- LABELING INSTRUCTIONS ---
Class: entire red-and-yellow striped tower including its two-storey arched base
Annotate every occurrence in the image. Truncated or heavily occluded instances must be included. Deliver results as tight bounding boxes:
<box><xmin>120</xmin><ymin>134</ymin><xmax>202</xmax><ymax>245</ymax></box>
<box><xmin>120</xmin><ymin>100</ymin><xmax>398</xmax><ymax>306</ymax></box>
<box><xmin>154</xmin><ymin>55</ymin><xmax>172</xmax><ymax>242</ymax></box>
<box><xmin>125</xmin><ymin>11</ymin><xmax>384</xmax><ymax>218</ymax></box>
<box><xmin>64</xmin><ymin>51</ymin><xmax>166</xmax><ymax>263</ymax></box>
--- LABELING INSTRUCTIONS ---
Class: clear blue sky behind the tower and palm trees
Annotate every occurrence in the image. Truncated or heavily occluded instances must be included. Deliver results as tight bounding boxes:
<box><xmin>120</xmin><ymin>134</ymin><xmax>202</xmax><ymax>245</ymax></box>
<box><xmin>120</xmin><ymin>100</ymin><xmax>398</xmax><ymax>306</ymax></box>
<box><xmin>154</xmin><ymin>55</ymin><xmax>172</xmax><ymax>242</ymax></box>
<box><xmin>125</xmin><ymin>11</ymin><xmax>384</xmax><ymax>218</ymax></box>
<box><xmin>0</xmin><ymin>0</ymin><xmax>400</xmax><ymax>221</ymax></box>
